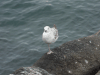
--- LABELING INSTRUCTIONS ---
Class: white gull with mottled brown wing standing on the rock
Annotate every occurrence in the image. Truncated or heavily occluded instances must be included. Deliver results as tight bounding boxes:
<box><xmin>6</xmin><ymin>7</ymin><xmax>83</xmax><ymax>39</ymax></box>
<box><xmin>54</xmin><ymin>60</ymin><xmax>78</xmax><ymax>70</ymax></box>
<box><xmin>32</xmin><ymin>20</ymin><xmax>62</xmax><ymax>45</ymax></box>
<box><xmin>42</xmin><ymin>24</ymin><xmax>58</xmax><ymax>54</ymax></box>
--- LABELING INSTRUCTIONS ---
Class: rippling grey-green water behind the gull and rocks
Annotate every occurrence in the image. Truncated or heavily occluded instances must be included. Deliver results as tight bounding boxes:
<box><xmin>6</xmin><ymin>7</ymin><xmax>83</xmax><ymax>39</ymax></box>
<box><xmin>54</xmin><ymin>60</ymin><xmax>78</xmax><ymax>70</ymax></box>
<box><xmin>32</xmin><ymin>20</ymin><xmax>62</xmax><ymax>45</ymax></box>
<box><xmin>0</xmin><ymin>0</ymin><xmax>100</xmax><ymax>75</ymax></box>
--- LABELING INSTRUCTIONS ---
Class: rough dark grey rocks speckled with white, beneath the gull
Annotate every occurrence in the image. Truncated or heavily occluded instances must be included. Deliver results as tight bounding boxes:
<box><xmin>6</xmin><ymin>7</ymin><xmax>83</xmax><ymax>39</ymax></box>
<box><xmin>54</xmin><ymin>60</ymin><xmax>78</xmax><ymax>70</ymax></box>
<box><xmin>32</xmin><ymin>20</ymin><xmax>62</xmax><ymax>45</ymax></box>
<box><xmin>13</xmin><ymin>31</ymin><xmax>100</xmax><ymax>75</ymax></box>
